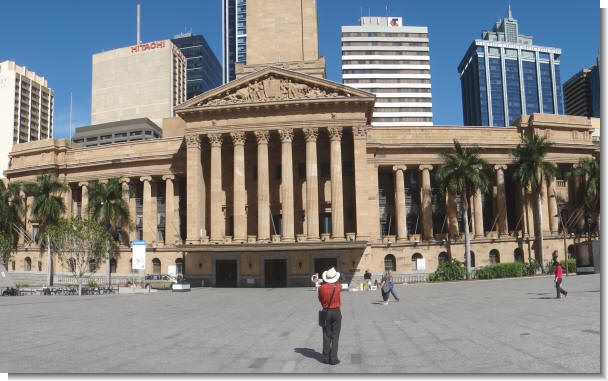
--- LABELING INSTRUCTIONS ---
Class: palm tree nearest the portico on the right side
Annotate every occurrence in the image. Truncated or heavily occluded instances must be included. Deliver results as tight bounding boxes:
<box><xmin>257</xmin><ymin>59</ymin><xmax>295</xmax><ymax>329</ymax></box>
<box><xmin>437</xmin><ymin>139</ymin><xmax>490</xmax><ymax>275</ymax></box>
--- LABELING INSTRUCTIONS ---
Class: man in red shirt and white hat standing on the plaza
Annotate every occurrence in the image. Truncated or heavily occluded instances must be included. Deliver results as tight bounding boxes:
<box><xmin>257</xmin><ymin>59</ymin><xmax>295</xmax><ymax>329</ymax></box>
<box><xmin>318</xmin><ymin>267</ymin><xmax>342</xmax><ymax>365</ymax></box>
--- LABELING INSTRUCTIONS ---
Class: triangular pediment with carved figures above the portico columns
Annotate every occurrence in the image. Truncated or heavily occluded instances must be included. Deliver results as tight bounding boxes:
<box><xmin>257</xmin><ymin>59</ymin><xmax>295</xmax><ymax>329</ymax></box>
<box><xmin>176</xmin><ymin>66</ymin><xmax>375</xmax><ymax>114</ymax></box>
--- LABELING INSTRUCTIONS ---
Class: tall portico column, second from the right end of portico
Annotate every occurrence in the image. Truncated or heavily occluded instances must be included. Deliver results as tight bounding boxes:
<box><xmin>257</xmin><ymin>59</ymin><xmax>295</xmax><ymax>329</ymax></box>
<box><xmin>327</xmin><ymin>127</ymin><xmax>344</xmax><ymax>239</ymax></box>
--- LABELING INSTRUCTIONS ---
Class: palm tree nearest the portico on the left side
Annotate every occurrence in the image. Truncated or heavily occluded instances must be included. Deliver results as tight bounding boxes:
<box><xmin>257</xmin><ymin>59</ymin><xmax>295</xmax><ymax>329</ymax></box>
<box><xmin>87</xmin><ymin>178</ymin><xmax>131</xmax><ymax>285</ymax></box>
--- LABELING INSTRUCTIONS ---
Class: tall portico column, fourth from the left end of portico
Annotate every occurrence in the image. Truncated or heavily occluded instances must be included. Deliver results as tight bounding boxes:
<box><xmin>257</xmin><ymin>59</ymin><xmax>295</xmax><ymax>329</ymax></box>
<box><xmin>255</xmin><ymin>131</ymin><xmax>270</xmax><ymax>242</ymax></box>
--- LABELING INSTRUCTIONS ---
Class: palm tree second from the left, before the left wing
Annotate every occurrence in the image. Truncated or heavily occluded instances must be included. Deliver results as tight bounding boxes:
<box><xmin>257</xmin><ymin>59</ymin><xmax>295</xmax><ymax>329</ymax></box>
<box><xmin>24</xmin><ymin>172</ymin><xmax>67</xmax><ymax>286</ymax></box>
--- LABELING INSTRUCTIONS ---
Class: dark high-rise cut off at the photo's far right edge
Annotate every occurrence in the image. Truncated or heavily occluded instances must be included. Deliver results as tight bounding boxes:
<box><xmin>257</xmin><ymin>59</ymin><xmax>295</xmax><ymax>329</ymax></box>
<box><xmin>564</xmin><ymin>65</ymin><xmax>600</xmax><ymax>118</ymax></box>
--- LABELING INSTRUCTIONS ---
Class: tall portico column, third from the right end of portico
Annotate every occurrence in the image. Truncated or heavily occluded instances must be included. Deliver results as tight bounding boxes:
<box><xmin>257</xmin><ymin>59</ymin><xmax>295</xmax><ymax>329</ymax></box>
<box><xmin>303</xmin><ymin>128</ymin><xmax>319</xmax><ymax>241</ymax></box>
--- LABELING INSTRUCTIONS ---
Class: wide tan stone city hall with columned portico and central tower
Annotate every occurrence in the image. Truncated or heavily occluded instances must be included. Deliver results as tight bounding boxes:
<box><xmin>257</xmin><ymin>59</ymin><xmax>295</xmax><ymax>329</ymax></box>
<box><xmin>5</xmin><ymin>1</ymin><xmax>599</xmax><ymax>287</ymax></box>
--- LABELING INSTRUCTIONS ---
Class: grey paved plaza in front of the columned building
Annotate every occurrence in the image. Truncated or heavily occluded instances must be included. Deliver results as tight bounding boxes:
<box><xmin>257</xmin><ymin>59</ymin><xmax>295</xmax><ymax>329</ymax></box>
<box><xmin>0</xmin><ymin>274</ymin><xmax>601</xmax><ymax>374</ymax></box>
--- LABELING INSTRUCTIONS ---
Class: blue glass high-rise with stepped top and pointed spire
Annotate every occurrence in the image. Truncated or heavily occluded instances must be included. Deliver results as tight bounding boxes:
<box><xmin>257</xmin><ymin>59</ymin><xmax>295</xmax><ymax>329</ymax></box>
<box><xmin>458</xmin><ymin>6</ymin><xmax>564</xmax><ymax>126</ymax></box>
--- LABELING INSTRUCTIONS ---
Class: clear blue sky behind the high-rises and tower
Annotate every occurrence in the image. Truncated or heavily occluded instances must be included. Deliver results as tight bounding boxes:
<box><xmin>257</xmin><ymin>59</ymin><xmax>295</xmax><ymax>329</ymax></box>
<box><xmin>0</xmin><ymin>0</ymin><xmax>600</xmax><ymax>138</ymax></box>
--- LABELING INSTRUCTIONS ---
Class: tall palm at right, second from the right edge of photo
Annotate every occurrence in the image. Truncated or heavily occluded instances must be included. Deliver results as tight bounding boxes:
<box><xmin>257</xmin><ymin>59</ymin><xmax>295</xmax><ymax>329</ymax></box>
<box><xmin>511</xmin><ymin>134</ymin><xmax>559</xmax><ymax>271</ymax></box>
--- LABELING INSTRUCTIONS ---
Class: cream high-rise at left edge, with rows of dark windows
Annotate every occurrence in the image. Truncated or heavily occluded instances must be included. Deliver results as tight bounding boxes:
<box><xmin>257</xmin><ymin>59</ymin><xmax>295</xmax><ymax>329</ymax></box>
<box><xmin>0</xmin><ymin>61</ymin><xmax>55</xmax><ymax>177</ymax></box>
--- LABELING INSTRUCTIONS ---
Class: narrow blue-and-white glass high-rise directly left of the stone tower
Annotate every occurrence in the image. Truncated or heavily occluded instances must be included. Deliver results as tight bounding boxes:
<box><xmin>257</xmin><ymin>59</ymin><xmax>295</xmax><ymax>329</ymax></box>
<box><xmin>222</xmin><ymin>0</ymin><xmax>247</xmax><ymax>83</ymax></box>
